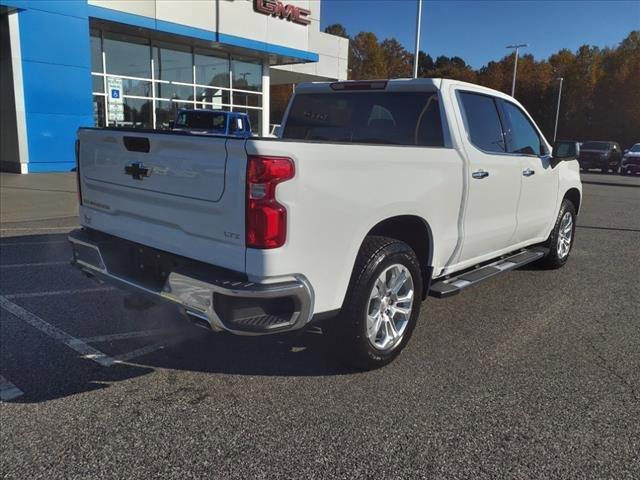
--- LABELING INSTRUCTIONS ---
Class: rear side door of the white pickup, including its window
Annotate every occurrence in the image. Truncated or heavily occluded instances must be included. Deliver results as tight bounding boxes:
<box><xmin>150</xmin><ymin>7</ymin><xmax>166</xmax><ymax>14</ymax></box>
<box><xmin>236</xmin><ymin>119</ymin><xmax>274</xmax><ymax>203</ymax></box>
<box><xmin>457</xmin><ymin>91</ymin><xmax>522</xmax><ymax>262</ymax></box>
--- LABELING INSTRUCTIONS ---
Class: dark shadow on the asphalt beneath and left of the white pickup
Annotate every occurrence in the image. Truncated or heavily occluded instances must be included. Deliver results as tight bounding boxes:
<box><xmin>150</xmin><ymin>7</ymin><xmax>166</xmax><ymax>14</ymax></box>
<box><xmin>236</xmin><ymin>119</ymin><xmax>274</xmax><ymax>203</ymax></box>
<box><xmin>0</xmin><ymin>233</ymin><xmax>350</xmax><ymax>403</ymax></box>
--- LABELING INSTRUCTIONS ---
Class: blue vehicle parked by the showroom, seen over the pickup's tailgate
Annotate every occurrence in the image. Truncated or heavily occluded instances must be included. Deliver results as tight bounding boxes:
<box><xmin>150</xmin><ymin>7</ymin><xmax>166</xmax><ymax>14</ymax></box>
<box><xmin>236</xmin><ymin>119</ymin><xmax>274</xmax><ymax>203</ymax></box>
<box><xmin>169</xmin><ymin>109</ymin><xmax>251</xmax><ymax>138</ymax></box>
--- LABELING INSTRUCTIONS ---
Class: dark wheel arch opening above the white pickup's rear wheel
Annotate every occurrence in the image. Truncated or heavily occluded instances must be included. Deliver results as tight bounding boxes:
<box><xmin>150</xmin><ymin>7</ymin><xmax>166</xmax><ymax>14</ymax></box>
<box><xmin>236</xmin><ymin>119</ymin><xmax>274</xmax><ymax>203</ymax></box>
<box><xmin>363</xmin><ymin>215</ymin><xmax>433</xmax><ymax>299</ymax></box>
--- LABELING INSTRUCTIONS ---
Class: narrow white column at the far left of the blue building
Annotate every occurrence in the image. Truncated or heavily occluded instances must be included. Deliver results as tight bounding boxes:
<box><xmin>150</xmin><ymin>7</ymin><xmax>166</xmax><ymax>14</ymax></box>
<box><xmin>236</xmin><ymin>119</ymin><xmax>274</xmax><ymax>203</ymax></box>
<box><xmin>8</xmin><ymin>12</ymin><xmax>29</xmax><ymax>173</ymax></box>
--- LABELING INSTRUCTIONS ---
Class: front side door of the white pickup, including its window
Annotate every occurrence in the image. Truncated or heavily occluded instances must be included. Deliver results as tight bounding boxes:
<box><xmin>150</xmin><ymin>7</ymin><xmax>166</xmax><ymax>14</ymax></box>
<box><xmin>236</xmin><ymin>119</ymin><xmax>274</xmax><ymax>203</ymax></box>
<box><xmin>499</xmin><ymin>100</ymin><xmax>558</xmax><ymax>243</ymax></box>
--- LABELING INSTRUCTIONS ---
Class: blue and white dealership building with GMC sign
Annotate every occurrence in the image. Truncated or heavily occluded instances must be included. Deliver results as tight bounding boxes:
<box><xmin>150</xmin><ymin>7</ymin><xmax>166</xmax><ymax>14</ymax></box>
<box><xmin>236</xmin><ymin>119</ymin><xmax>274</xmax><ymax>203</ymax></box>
<box><xmin>0</xmin><ymin>0</ymin><xmax>348</xmax><ymax>173</ymax></box>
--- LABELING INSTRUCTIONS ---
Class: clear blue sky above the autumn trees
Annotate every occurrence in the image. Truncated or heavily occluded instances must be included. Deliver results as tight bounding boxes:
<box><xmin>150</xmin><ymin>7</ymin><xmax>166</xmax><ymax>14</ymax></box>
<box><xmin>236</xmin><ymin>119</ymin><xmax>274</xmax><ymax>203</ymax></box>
<box><xmin>321</xmin><ymin>0</ymin><xmax>640</xmax><ymax>68</ymax></box>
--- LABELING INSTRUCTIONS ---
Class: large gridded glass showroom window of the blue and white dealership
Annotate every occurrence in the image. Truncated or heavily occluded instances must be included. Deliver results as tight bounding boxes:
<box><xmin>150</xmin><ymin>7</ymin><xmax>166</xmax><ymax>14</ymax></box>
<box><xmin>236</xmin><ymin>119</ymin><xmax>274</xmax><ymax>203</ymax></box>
<box><xmin>91</xmin><ymin>29</ymin><xmax>262</xmax><ymax>133</ymax></box>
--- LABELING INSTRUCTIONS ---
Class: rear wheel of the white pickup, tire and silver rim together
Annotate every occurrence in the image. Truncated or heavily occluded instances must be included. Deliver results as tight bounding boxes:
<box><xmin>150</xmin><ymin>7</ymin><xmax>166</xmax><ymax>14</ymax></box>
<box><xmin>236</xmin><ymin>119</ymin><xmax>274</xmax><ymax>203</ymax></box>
<box><xmin>326</xmin><ymin>236</ymin><xmax>422</xmax><ymax>370</ymax></box>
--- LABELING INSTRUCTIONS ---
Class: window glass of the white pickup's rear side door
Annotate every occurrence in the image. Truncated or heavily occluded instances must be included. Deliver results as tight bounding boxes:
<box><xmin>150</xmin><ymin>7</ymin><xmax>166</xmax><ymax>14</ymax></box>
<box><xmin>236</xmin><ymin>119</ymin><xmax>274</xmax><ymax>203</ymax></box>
<box><xmin>460</xmin><ymin>92</ymin><xmax>505</xmax><ymax>153</ymax></box>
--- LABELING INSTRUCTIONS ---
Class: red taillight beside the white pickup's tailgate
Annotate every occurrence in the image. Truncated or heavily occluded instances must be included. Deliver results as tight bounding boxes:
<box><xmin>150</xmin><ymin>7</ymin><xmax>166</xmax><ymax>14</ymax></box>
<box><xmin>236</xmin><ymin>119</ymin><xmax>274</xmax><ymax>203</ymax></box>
<box><xmin>246</xmin><ymin>155</ymin><xmax>294</xmax><ymax>249</ymax></box>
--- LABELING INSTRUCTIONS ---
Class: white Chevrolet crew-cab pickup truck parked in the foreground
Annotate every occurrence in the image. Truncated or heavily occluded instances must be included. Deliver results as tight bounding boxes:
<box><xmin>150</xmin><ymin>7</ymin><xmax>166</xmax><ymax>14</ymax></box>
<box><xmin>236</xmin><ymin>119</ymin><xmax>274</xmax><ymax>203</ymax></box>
<box><xmin>69</xmin><ymin>79</ymin><xmax>582</xmax><ymax>369</ymax></box>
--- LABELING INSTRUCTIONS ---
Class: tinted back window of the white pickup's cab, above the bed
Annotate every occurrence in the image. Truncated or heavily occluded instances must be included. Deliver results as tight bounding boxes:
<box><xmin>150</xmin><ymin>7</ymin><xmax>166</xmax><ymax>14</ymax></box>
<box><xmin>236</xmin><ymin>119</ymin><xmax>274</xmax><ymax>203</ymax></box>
<box><xmin>282</xmin><ymin>92</ymin><xmax>444</xmax><ymax>147</ymax></box>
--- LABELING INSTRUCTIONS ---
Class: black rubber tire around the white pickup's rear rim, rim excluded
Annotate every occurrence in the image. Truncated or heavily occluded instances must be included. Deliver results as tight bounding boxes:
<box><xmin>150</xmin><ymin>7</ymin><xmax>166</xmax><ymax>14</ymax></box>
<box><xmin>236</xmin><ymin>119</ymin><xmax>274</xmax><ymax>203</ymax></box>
<box><xmin>324</xmin><ymin>236</ymin><xmax>423</xmax><ymax>370</ymax></box>
